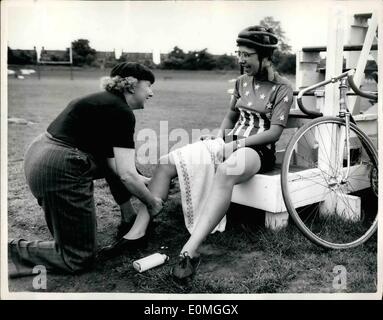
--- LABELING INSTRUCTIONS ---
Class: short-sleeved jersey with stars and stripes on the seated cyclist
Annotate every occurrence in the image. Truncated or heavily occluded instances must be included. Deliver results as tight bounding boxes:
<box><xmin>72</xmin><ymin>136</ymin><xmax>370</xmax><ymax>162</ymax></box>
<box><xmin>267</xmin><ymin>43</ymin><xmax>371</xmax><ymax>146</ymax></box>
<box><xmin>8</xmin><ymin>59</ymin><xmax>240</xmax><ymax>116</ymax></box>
<box><xmin>228</xmin><ymin>74</ymin><xmax>293</xmax><ymax>150</ymax></box>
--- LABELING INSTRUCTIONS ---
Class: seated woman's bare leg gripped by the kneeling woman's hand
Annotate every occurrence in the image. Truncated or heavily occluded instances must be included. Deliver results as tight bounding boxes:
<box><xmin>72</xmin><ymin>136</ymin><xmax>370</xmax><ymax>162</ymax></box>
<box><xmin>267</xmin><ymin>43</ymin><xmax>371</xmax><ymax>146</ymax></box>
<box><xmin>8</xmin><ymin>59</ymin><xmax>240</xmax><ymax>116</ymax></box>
<box><xmin>124</xmin><ymin>155</ymin><xmax>177</xmax><ymax>240</ymax></box>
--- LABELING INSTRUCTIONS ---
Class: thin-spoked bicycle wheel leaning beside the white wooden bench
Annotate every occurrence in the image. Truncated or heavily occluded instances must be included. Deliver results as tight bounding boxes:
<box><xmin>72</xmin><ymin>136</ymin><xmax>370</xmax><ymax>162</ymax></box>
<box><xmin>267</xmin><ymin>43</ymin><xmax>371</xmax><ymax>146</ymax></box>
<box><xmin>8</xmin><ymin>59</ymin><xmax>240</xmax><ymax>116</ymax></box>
<box><xmin>281</xmin><ymin>117</ymin><xmax>378</xmax><ymax>249</ymax></box>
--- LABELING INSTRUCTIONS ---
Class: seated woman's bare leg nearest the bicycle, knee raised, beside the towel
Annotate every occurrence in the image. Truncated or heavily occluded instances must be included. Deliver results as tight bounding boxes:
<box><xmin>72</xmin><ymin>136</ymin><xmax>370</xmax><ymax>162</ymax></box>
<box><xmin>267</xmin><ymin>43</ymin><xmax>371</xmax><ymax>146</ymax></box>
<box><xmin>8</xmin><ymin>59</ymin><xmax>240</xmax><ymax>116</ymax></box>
<box><xmin>181</xmin><ymin>148</ymin><xmax>261</xmax><ymax>258</ymax></box>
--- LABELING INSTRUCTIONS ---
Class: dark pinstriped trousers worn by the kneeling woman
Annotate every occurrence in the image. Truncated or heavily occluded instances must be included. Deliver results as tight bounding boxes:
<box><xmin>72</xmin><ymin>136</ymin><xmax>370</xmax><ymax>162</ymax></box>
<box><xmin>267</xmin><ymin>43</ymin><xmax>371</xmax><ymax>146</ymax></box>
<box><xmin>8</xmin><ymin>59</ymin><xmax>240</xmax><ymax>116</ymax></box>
<box><xmin>8</xmin><ymin>133</ymin><xmax>131</xmax><ymax>273</ymax></box>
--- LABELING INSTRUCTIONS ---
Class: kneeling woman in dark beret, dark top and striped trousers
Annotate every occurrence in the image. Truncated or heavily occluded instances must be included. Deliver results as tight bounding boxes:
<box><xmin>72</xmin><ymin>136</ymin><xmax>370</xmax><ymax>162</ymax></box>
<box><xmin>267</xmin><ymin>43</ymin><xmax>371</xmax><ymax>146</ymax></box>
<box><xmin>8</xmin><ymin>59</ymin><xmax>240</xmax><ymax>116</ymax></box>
<box><xmin>8</xmin><ymin>62</ymin><xmax>162</xmax><ymax>276</ymax></box>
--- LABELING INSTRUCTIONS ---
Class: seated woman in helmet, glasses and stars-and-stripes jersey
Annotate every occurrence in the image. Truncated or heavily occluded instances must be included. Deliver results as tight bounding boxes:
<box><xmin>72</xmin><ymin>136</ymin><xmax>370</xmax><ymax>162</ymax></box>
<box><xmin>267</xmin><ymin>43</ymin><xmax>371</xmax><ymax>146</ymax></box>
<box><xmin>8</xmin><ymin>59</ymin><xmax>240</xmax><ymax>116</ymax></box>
<box><xmin>102</xmin><ymin>26</ymin><xmax>293</xmax><ymax>279</ymax></box>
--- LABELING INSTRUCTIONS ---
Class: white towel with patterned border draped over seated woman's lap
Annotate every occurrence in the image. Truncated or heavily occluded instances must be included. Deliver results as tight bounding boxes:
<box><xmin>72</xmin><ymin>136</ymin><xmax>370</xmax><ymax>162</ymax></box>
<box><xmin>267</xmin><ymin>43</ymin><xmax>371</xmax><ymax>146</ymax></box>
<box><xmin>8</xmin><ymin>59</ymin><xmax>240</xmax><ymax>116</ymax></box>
<box><xmin>170</xmin><ymin>138</ymin><xmax>226</xmax><ymax>233</ymax></box>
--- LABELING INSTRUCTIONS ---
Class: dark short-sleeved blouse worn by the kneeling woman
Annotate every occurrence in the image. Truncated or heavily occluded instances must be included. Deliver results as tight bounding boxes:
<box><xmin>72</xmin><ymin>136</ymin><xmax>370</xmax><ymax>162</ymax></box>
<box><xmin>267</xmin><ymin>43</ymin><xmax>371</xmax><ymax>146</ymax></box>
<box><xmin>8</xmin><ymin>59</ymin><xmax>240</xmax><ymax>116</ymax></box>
<box><xmin>47</xmin><ymin>91</ymin><xmax>136</xmax><ymax>158</ymax></box>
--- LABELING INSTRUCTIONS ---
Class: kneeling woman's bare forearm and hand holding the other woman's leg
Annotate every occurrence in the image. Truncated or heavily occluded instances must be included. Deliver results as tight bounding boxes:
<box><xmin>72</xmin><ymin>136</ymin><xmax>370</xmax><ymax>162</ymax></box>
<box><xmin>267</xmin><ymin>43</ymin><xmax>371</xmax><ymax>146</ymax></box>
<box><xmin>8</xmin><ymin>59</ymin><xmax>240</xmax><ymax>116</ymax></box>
<box><xmin>108</xmin><ymin>148</ymin><xmax>162</xmax><ymax>213</ymax></box>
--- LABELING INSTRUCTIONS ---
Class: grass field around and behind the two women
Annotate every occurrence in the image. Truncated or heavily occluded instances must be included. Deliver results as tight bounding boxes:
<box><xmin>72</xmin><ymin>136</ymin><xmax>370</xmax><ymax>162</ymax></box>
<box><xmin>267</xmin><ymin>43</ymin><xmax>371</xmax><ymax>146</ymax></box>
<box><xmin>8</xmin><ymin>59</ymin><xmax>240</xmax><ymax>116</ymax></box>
<box><xmin>8</xmin><ymin>67</ymin><xmax>377</xmax><ymax>293</ymax></box>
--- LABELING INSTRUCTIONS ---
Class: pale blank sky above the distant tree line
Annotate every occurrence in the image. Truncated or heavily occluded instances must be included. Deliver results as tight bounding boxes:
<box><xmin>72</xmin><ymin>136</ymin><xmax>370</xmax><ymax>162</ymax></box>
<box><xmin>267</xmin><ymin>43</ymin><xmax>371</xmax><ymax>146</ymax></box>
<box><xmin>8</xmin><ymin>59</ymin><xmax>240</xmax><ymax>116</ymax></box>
<box><xmin>2</xmin><ymin>0</ymin><xmax>382</xmax><ymax>54</ymax></box>
